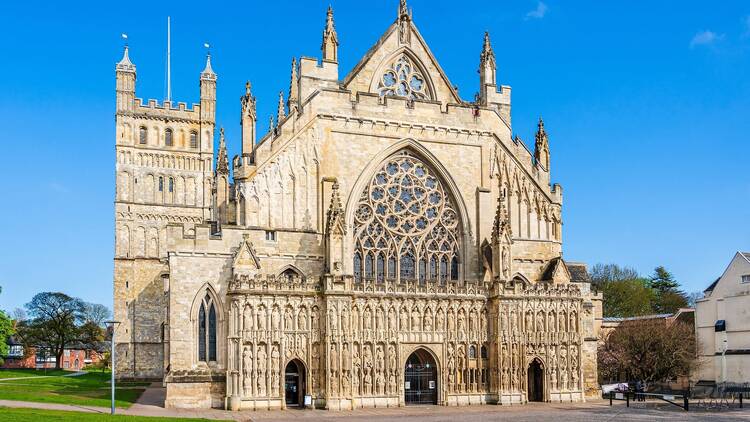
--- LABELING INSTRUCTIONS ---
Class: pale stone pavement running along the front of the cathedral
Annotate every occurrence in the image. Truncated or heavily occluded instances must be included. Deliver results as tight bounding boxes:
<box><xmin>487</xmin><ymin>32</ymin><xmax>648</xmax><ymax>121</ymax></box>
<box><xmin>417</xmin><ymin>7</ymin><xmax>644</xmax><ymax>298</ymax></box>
<box><xmin>0</xmin><ymin>383</ymin><xmax>750</xmax><ymax>422</ymax></box>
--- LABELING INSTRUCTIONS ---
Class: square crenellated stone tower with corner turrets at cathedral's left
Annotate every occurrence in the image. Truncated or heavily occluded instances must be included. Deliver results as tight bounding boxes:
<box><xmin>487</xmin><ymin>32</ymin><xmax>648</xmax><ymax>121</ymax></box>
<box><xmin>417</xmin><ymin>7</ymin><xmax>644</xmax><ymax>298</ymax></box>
<box><xmin>114</xmin><ymin>47</ymin><xmax>217</xmax><ymax>378</ymax></box>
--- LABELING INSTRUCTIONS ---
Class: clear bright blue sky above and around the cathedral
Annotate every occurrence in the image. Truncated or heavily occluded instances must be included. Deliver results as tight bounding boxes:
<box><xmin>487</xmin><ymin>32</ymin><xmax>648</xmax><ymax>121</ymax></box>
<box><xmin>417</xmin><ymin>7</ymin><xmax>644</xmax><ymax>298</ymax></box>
<box><xmin>0</xmin><ymin>0</ymin><xmax>750</xmax><ymax>311</ymax></box>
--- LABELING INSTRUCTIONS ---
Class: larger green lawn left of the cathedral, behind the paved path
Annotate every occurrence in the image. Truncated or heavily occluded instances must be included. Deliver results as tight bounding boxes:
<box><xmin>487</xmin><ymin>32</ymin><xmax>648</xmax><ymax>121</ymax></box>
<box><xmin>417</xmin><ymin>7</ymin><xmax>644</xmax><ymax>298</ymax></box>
<box><xmin>0</xmin><ymin>372</ymin><xmax>148</xmax><ymax>408</ymax></box>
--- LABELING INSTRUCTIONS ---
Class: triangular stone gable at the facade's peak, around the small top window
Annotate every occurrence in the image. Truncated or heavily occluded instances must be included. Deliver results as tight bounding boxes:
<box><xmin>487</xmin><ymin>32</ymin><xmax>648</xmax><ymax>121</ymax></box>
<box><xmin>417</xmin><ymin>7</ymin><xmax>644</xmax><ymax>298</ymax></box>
<box><xmin>342</xmin><ymin>20</ymin><xmax>462</xmax><ymax>104</ymax></box>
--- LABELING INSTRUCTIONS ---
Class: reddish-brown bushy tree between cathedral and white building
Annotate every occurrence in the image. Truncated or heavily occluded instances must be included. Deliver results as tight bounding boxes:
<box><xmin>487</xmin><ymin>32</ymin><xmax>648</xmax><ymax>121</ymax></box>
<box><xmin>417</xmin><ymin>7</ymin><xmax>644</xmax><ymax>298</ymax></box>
<box><xmin>597</xmin><ymin>318</ymin><xmax>697</xmax><ymax>383</ymax></box>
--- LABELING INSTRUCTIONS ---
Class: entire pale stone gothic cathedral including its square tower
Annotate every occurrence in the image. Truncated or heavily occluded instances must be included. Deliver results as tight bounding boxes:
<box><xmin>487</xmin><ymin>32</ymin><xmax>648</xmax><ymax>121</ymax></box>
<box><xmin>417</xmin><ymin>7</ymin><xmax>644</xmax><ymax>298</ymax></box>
<box><xmin>114</xmin><ymin>0</ymin><xmax>602</xmax><ymax>410</ymax></box>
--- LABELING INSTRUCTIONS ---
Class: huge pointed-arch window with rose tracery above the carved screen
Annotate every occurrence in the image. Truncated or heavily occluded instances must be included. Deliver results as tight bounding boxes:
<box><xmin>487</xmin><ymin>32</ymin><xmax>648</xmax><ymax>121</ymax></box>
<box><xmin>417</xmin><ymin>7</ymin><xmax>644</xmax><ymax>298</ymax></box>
<box><xmin>354</xmin><ymin>151</ymin><xmax>460</xmax><ymax>283</ymax></box>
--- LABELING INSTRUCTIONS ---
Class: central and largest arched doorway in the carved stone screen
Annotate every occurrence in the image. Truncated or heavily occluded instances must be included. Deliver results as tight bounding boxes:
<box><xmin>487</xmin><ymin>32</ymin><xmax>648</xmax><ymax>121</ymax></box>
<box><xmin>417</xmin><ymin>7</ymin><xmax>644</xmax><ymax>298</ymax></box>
<box><xmin>404</xmin><ymin>349</ymin><xmax>438</xmax><ymax>404</ymax></box>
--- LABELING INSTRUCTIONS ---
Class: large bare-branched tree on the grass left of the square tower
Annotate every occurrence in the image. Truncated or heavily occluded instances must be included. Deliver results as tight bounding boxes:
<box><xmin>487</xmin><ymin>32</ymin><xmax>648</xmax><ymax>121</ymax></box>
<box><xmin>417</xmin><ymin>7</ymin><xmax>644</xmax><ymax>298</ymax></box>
<box><xmin>18</xmin><ymin>292</ymin><xmax>103</xmax><ymax>369</ymax></box>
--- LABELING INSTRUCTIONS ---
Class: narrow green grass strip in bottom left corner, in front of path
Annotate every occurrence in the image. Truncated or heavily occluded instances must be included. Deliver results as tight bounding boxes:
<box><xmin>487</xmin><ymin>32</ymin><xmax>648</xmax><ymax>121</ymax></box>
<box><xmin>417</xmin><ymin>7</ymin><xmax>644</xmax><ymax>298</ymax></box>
<box><xmin>0</xmin><ymin>407</ymin><xmax>220</xmax><ymax>422</ymax></box>
